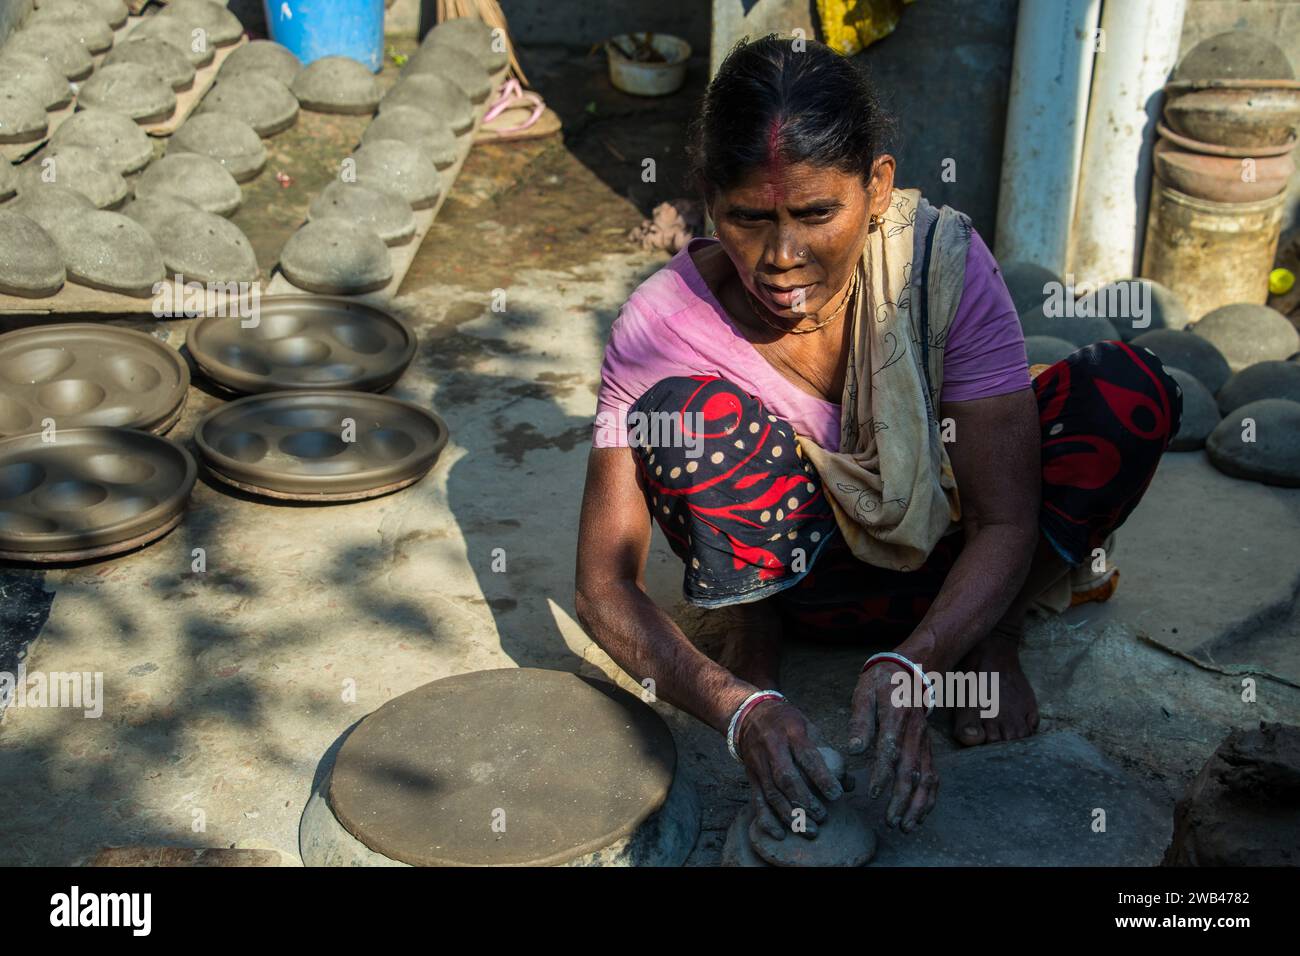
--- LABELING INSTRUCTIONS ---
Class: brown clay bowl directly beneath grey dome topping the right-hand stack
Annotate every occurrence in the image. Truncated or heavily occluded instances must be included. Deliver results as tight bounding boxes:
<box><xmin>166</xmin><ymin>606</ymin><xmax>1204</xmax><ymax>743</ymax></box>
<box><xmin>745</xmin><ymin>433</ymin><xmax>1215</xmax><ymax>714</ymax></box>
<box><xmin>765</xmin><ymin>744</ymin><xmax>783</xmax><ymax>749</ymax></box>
<box><xmin>1165</xmin><ymin>88</ymin><xmax>1300</xmax><ymax>148</ymax></box>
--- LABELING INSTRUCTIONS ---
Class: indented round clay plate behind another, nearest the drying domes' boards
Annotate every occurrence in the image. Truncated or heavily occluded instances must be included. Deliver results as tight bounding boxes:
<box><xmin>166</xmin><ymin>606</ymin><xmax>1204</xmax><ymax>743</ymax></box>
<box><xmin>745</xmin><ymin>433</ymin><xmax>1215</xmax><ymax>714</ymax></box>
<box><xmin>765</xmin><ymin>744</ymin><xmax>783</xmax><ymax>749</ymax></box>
<box><xmin>186</xmin><ymin>295</ymin><xmax>415</xmax><ymax>394</ymax></box>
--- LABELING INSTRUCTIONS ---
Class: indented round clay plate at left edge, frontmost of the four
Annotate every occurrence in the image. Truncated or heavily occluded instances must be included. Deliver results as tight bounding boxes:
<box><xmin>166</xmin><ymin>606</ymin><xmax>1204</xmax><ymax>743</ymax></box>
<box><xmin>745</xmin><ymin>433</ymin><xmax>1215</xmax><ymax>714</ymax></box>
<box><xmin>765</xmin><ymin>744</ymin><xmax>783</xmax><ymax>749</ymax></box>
<box><xmin>0</xmin><ymin>428</ymin><xmax>198</xmax><ymax>562</ymax></box>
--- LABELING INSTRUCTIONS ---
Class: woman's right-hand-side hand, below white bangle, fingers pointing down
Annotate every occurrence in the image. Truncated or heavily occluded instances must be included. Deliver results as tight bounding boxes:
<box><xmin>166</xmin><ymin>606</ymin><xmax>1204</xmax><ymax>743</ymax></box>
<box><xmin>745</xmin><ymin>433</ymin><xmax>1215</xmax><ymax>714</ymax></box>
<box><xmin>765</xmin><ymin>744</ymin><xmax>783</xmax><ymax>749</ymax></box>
<box><xmin>849</xmin><ymin>663</ymin><xmax>939</xmax><ymax>834</ymax></box>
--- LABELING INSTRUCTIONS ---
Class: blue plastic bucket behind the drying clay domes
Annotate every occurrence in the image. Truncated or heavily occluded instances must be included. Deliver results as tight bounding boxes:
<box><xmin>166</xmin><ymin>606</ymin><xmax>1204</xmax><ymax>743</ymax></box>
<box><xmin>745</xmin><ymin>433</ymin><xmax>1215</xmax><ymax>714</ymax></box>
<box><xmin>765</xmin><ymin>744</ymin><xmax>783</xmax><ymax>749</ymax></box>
<box><xmin>263</xmin><ymin>0</ymin><xmax>384</xmax><ymax>73</ymax></box>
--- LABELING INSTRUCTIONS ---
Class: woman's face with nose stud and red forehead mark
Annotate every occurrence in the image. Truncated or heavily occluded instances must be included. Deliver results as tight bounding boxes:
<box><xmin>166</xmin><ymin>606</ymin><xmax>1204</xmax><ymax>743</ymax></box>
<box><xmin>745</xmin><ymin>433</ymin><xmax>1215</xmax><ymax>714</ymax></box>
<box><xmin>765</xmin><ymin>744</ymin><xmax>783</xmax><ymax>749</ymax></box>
<box><xmin>710</xmin><ymin>156</ymin><xmax>894</xmax><ymax>325</ymax></box>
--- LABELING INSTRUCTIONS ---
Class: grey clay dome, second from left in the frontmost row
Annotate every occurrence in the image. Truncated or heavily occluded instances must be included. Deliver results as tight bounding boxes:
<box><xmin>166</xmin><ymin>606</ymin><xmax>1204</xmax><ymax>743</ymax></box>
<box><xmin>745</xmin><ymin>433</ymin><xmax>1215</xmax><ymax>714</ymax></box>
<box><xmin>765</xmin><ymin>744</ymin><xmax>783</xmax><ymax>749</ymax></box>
<box><xmin>47</xmin><ymin>212</ymin><xmax>163</xmax><ymax>297</ymax></box>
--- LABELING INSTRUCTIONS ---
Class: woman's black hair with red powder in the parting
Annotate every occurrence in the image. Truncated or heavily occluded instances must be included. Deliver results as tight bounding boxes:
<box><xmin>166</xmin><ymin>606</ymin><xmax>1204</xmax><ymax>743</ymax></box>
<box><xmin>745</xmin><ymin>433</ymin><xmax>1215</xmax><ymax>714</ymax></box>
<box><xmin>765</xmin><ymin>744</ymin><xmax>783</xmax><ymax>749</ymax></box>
<box><xmin>689</xmin><ymin>34</ymin><xmax>893</xmax><ymax>202</ymax></box>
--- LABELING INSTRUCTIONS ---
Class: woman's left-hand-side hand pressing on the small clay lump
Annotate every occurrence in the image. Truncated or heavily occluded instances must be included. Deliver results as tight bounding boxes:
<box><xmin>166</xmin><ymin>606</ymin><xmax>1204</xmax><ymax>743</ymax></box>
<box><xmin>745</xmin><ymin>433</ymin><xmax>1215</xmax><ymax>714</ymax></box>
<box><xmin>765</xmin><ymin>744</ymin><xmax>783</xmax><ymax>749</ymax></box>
<box><xmin>738</xmin><ymin>700</ymin><xmax>853</xmax><ymax>840</ymax></box>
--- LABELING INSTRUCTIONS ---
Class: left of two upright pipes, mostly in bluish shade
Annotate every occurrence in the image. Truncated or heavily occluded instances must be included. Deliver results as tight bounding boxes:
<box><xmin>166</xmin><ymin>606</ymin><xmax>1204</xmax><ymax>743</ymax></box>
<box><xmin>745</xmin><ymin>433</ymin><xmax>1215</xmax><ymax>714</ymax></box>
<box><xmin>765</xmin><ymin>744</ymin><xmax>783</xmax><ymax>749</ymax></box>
<box><xmin>995</xmin><ymin>0</ymin><xmax>1101</xmax><ymax>274</ymax></box>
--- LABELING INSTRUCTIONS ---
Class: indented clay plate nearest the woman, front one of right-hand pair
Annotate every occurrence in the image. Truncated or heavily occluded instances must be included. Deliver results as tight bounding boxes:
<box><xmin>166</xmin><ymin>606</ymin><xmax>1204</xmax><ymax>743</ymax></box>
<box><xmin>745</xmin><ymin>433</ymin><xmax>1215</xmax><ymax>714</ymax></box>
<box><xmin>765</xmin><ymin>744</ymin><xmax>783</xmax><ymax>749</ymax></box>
<box><xmin>194</xmin><ymin>390</ymin><xmax>447</xmax><ymax>501</ymax></box>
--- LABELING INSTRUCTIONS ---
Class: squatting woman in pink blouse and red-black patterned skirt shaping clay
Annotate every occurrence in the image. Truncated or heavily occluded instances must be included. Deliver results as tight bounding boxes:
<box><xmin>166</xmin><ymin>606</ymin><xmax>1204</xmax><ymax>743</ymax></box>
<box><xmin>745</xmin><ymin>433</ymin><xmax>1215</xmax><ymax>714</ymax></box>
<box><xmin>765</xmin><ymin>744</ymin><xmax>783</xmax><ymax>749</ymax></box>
<box><xmin>577</xmin><ymin>36</ymin><xmax>1182</xmax><ymax>838</ymax></box>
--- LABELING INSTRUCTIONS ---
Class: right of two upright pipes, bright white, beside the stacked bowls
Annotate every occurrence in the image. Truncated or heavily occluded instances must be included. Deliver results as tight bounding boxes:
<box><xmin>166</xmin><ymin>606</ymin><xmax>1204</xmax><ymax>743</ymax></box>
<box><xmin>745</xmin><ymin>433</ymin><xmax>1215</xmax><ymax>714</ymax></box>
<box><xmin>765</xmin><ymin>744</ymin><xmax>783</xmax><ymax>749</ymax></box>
<box><xmin>1071</xmin><ymin>0</ymin><xmax>1187</xmax><ymax>287</ymax></box>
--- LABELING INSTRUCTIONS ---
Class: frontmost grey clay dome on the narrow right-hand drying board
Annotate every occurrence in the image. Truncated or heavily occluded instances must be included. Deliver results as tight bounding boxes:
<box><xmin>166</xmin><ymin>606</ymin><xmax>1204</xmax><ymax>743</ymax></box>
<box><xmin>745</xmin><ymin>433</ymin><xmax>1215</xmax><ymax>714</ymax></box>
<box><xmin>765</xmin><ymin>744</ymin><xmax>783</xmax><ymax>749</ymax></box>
<box><xmin>280</xmin><ymin>219</ymin><xmax>393</xmax><ymax>295</ymax></box>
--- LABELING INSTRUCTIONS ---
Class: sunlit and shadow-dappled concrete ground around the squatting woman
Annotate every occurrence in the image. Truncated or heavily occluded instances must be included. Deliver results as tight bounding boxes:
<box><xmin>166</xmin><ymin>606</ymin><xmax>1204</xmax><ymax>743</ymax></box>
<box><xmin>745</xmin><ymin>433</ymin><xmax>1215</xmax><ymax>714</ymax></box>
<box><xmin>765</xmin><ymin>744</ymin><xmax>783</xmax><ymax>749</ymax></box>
<box><xmin>0</xmin><ymin>42</ymin><xmax>1300</xmax><ymax>865</ymax></box>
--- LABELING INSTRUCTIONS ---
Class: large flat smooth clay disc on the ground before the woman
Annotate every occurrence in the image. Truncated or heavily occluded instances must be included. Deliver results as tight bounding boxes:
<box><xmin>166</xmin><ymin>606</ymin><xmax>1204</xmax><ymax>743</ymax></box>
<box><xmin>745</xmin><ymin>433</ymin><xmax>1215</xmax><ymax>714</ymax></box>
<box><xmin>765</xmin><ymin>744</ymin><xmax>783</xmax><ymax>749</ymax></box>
<box><xmin>329</xmin><ymin>667</ymin><xmax>677</xmax><ymax>866</ymax></box>
